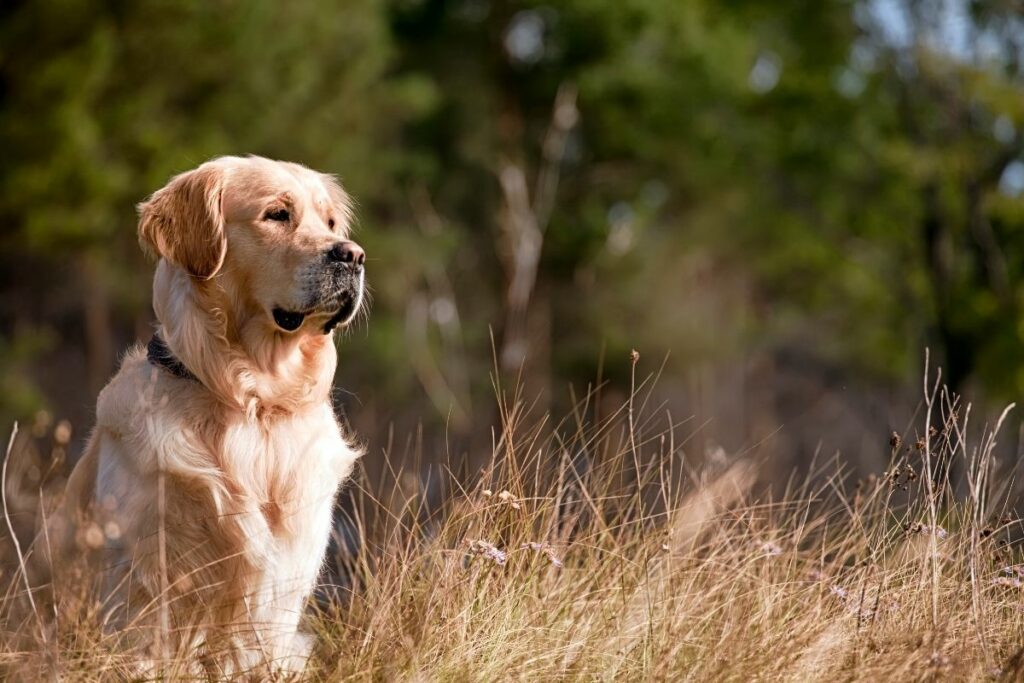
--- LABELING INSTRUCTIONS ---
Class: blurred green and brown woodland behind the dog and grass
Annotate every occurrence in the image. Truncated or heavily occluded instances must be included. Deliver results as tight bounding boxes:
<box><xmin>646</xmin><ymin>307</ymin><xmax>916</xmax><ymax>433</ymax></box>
<box><xmin>0</xmin><ymin>0</ymin><xmax>1024</xmax><ymax>485</ymax></box>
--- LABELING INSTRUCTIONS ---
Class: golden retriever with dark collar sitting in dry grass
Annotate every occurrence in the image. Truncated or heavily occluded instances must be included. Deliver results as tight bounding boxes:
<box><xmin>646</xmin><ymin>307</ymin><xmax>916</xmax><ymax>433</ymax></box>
<box><xmin>31</xmin><ymin>157</ymin><xmax>366</xmax><ymax>675</ymax></box>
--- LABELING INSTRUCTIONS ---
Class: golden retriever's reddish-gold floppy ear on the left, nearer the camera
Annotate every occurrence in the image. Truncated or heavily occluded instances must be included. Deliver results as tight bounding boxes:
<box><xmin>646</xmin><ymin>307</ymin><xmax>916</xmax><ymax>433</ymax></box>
<box><xmin>138</xmin><ymin>164</ymin><xmax>227</xmax><ymax>280</ymax></box>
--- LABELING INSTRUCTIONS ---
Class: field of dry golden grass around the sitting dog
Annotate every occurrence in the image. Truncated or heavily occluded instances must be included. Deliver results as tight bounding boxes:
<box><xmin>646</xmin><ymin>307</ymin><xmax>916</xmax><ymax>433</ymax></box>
<box><xmin>0</xmin><ymin>362</ymin><xmax>1024</xmax><ymax>681</ymax></box>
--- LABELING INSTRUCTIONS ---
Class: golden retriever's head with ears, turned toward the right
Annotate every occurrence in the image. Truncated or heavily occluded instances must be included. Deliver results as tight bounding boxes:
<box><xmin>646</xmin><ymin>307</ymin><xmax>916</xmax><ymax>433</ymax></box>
<box><xmin>138</xmin><ymin>157</ymin><xmax>366</xmax><ymax>335</ymax></box>
